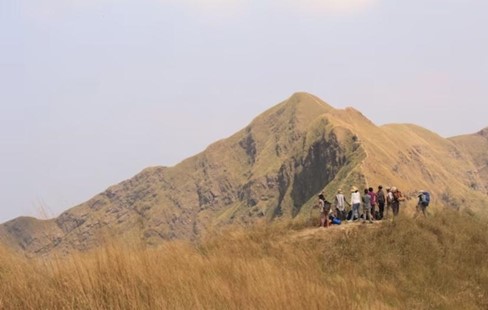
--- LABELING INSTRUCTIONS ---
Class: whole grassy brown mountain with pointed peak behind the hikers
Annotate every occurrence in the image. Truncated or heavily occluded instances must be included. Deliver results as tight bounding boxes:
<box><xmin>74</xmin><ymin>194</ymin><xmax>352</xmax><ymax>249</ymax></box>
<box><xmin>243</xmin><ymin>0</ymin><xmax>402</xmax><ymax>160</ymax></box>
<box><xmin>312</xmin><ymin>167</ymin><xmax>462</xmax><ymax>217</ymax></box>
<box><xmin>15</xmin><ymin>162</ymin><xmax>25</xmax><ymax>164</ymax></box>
<box><xmin>0</xmin><ymin>93</ymin><xmax>488</xmax><ymax>255</ymax></box>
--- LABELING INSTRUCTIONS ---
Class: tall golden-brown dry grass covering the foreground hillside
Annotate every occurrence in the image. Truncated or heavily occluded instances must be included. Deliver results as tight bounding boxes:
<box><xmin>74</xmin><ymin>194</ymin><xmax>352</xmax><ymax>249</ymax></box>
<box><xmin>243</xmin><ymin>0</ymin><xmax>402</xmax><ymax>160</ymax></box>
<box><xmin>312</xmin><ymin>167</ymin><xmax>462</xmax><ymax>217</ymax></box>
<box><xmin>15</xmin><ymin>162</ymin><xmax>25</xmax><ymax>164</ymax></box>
<box><xmin>0</xmin><ymin>211</ymin><xmax>488</xmax><ymax>309</ymax></box>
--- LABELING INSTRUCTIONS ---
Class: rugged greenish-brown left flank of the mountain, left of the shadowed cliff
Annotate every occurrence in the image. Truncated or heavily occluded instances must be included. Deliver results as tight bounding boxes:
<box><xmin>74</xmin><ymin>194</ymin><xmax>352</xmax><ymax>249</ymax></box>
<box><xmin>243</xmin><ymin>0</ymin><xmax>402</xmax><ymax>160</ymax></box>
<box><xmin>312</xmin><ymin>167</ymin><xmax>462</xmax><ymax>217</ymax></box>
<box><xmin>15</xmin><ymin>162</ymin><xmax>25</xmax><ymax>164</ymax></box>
<box><xmin>0</xmin><ymin>93</ymin><xmax>342</xmax><ymax>252</ymax></box>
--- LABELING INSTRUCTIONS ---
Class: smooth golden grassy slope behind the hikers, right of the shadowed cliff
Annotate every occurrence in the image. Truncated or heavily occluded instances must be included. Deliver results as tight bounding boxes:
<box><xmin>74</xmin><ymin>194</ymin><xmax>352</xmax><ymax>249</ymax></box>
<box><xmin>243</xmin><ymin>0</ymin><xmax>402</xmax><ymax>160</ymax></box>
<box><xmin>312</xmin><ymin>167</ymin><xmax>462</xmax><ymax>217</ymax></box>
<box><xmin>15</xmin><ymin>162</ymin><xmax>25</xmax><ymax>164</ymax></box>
<box><xmin>318</xmin><ymin>108</ymin><xmax>488</xmax><ymax>214</ymax></box>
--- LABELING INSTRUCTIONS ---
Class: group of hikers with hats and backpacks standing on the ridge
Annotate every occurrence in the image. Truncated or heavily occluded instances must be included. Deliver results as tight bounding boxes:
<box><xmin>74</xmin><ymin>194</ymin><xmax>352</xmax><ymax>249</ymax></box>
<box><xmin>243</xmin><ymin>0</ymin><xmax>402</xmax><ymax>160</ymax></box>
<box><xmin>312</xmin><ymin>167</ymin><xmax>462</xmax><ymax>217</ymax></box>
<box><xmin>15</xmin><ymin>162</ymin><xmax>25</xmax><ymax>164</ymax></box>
<box><xmin>318</xmin><ymin>185</ymin><xmax>430</xmax><ymax>227</ymax></box>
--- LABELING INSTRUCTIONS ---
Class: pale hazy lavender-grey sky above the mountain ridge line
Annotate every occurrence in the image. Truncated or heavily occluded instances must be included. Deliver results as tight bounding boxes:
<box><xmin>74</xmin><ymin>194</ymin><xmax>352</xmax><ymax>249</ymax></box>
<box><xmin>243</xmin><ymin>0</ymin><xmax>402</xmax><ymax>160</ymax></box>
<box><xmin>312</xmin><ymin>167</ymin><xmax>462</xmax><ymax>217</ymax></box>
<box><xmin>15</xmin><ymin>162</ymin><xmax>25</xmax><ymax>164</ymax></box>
<box><xmin>0</xmin><ymin>0</ymin><xmax>488</xmax><ymax>222</ymax></box>
